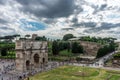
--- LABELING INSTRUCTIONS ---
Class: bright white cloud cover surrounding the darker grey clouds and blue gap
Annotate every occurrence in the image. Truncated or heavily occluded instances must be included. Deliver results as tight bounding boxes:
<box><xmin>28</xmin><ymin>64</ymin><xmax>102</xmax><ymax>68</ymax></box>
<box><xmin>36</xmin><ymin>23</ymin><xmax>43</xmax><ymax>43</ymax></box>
<box><xmin>0</xmin><ymin>0</ymin><xmax>120</xmax><ymax>38</ymax></box>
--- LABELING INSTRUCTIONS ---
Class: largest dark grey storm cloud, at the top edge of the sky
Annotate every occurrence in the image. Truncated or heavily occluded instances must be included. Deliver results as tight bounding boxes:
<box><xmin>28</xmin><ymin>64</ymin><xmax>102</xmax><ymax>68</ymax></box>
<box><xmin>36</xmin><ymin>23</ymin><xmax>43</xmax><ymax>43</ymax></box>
<box><xmin>16</xmin><ymin>0</ymin><xmax>75</xmax><ymax>18</ymax></box>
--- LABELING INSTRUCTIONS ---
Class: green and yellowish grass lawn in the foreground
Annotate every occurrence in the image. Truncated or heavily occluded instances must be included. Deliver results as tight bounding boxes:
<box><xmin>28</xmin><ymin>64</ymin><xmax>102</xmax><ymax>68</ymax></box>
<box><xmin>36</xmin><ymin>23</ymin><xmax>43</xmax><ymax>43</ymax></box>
<box><xmin>30</xmin><ymin>66</ymin><xmax>120</xmax><ymax>80</ymax></box>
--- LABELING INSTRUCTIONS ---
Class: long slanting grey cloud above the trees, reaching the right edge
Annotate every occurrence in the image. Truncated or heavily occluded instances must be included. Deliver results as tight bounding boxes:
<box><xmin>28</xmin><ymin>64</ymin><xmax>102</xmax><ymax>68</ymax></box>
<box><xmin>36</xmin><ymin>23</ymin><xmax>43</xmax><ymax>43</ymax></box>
<box><xmin>85</xmin><ymin>22</ymin><xmax>120</xmax><ymax>33</ymax></box>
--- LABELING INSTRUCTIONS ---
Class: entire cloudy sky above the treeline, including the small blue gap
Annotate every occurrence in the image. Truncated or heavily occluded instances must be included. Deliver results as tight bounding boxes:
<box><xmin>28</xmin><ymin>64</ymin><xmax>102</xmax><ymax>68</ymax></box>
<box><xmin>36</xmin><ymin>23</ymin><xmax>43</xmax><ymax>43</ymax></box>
<box><xmin>0</xmin><ymin>0</ymin><xmax>120</xmax><ymax>39</ymax></box>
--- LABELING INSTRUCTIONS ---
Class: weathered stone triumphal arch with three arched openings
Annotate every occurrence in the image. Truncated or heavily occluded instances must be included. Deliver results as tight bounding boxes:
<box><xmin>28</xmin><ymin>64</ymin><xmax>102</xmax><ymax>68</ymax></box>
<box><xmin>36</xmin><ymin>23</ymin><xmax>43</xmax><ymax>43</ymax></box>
<box><xmin>16</xmin><ymin>40</ymin><xmax>48</xmax><ymax>72</ymax></box>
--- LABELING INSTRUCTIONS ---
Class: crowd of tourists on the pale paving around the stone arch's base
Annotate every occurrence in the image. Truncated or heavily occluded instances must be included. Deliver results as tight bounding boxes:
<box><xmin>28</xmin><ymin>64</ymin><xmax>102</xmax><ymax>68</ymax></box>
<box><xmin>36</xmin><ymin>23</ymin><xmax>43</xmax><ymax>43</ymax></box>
<box><xmin>0</xmin><ymin>59</ymin><xmax>103</xmax><ymax>80</ymax></box>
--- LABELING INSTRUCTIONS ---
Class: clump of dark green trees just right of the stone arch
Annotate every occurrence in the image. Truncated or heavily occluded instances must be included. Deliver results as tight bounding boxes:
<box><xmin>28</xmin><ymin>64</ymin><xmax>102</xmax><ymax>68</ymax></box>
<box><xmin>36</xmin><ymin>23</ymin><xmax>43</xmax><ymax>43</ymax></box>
<box><xmin>52</xmin><ymin>41</ymin><xmax>83</xmax><ymax>55</ymax></box>
